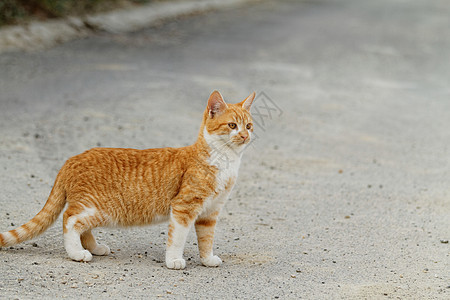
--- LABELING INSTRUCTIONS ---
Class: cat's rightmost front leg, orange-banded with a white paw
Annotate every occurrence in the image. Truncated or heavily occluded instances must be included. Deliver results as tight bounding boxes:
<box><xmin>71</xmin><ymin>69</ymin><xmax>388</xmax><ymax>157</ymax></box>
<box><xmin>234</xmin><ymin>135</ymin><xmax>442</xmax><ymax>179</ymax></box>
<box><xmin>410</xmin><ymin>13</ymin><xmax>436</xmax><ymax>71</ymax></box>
<box><xmin>195</xmin><ymin>211</ymin><xmax>222</xmax><ymax>267</ymax></box>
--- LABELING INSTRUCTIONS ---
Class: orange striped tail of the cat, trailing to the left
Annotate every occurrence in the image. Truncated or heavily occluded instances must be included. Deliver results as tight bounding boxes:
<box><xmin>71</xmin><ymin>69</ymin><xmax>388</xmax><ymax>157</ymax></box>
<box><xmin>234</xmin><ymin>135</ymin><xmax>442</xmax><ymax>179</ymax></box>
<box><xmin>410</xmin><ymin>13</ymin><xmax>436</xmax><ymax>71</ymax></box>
<box><xmin>0</xmin><ymin>174</ymin><xmax>66</xmax><ymax>247</ymax></box>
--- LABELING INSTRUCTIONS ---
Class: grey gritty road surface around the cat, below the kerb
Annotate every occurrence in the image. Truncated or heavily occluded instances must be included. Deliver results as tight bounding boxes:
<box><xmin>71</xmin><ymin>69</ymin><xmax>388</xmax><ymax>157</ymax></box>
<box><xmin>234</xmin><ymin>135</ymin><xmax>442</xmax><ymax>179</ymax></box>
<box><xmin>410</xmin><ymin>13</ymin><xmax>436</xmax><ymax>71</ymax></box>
<box><xmin>0</xmin><ymin>0</ymin><xmax>450</xmax><ymax>299</ymax></box>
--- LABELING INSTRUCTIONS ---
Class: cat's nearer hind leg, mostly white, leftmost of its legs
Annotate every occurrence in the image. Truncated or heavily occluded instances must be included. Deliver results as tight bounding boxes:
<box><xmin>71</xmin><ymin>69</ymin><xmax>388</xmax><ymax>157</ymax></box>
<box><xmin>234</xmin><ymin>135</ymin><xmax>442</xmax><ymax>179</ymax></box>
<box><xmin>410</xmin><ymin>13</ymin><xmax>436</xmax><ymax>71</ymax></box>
<box><xmin>63</xmin><ymin>204</ymin><xmax>104</xmax><ymax>261</ymax></box>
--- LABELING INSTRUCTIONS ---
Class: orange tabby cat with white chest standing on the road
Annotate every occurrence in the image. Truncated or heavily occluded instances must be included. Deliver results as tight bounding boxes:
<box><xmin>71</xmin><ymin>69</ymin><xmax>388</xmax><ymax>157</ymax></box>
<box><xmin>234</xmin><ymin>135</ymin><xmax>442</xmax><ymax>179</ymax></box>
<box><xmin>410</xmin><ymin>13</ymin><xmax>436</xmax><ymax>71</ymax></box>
<box><xmin>0</xmin><ymin>91</ymin><xmax>255</xmax><ymax>269</ymax></box>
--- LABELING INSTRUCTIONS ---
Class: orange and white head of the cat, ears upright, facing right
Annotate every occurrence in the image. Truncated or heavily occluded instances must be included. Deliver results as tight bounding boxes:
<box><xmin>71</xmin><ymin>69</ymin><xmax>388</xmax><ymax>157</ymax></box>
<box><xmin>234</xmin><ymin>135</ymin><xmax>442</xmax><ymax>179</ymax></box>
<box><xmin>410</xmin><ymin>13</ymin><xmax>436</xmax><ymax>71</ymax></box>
<box><xmin>203</xmin><ymin>91</ymin><xmax>255</xmax><ymax>148</ymax></box>
